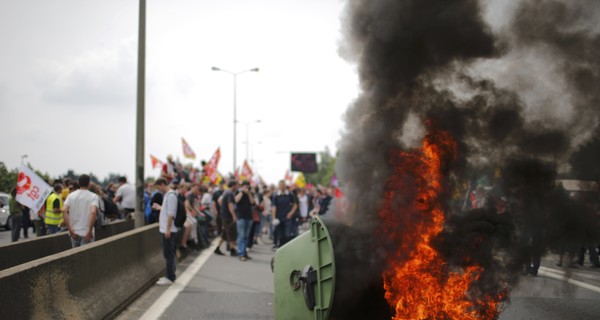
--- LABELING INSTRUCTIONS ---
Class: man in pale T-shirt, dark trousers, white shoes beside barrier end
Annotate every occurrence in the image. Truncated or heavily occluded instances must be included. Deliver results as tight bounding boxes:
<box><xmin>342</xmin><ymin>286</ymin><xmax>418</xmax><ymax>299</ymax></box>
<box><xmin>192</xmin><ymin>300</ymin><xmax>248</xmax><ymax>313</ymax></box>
<box><xmin>152</xmin><ymin>178</ymin><xmax>179</xmax><ymax>286</ymax></box>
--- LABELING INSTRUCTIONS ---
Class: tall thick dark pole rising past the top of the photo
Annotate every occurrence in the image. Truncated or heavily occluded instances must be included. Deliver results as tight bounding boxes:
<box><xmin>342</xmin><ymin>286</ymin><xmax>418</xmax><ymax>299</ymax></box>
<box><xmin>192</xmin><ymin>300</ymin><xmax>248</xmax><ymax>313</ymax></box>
<box><xmin>133</xmin><ymin>0</ymin><xmax>146</xmax><ymax>228</ymax></box>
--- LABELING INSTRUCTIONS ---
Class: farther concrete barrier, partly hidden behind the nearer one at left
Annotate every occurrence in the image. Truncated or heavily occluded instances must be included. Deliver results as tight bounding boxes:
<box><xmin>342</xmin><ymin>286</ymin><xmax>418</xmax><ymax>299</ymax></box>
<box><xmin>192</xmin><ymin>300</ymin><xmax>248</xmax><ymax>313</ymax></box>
<box><xmin>0</xmin><ymin>220</ymin><xmax>134</xmax><ymax>270</ymax></box>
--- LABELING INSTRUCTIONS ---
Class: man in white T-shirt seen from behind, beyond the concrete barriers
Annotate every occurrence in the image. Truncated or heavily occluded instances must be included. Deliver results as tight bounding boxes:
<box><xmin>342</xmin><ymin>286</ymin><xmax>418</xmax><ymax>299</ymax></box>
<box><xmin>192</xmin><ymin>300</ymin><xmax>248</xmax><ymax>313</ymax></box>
<box><xmin>63</xmin><ymin>174</ymin><xmax>98</xmax><ymax>248</ymax></box>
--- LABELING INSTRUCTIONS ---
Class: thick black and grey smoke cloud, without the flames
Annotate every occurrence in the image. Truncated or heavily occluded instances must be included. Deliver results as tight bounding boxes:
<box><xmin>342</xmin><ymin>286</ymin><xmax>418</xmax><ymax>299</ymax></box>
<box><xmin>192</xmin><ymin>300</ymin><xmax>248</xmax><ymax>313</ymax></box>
<box><xmin>336</xmin><ymin>0</ymin><xmax>600</xmax><ymax>316</ymax></box>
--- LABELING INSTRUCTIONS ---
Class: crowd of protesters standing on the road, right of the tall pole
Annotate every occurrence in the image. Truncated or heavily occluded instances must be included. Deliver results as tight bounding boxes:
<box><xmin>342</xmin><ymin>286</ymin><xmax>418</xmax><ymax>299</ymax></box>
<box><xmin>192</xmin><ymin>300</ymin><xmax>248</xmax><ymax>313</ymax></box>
<box><xmin>150</xmin><ymin>157</ymin><xmax>334</xmax><ymax>285</ymax></box>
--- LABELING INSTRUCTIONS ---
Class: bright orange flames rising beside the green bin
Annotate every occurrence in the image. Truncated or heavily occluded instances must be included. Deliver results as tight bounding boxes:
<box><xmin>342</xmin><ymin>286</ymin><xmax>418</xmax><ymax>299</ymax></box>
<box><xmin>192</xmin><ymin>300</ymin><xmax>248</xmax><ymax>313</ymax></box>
<box><xmin>379</xmin><ymin>131</ymin><xmax>505</xmax><ymax>319</ymax></box>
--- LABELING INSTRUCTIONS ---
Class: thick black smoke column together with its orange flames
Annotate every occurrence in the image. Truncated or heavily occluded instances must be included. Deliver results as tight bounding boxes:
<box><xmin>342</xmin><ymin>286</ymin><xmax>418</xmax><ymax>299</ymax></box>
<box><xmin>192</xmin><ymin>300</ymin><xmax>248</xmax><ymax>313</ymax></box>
<box><xmin>337</xmin><ymin>0</ymin><xmax>600</xmax><ymax>319</ymax></box>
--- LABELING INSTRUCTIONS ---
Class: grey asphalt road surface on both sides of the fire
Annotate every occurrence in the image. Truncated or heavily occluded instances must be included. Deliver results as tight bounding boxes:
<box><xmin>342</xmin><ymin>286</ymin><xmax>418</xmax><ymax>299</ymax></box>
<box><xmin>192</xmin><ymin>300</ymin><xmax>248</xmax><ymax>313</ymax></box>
<box><xmin>113</xmin><ymin>238</ymin><xmax>600</xmax><ymax>320</ymax></box>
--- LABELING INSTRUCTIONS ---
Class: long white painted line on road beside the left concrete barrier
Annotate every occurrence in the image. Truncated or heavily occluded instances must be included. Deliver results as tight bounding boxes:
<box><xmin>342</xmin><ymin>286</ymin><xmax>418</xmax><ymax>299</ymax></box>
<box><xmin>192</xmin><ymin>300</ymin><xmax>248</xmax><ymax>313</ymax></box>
<box><xmin>140</xmin><ymin>238</ymin><xmax>220</xmax><ymax>320</ymax></box>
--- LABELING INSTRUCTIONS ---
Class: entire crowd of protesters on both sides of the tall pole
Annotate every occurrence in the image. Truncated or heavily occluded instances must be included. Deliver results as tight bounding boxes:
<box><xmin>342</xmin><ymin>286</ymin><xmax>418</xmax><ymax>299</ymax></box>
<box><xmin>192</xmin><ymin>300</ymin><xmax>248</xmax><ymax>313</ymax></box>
<box><xmin>0</xmin><ymin>157</ymin><xmax>335</xmax><ymax>285</ymax></box>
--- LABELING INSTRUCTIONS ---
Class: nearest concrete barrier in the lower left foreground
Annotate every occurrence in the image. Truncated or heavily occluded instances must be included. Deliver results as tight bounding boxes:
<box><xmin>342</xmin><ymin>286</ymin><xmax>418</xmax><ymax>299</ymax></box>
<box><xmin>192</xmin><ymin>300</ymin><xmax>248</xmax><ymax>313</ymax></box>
<box><xmin>0</xmin><ymin>224</ymin><xmax>165</xmax><ymax>319</ymax></box>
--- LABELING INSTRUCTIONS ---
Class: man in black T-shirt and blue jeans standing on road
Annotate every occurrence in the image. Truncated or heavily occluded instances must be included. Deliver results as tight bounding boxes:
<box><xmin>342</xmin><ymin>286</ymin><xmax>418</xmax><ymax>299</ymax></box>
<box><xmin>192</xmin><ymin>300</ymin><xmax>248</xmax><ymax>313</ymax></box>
<box><xmin>235</xmin><ymin>181</ymin><xmax>254</xmax><ymax>261</ymax></box>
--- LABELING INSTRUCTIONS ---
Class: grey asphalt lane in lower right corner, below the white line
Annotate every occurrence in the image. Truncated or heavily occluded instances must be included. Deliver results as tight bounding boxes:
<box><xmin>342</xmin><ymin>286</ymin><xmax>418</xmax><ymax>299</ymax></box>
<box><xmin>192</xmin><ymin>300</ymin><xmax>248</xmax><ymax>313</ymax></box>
<box><xmin>500</xmin><ymin>276</ymin><xmax>600</xmax><ymax>320</ymax></box>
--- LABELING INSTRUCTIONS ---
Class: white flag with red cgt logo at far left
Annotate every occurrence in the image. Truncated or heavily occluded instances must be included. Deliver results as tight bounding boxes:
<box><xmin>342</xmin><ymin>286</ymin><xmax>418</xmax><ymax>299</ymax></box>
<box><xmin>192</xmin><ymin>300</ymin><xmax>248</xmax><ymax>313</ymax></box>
<box><xmin>15</xmin><ymin>164</ymin><xmax>52</xmax><ymax>213</ymax></box>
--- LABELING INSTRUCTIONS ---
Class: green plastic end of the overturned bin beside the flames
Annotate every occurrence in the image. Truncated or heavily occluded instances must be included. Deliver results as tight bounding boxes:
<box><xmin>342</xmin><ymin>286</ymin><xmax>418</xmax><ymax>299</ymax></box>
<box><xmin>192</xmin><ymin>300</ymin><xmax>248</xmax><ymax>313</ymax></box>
<box><xmin>273</xmin><ymin>217</ymin><xmax>335</xmax><ymax>320</ymax></box>
